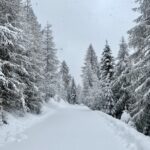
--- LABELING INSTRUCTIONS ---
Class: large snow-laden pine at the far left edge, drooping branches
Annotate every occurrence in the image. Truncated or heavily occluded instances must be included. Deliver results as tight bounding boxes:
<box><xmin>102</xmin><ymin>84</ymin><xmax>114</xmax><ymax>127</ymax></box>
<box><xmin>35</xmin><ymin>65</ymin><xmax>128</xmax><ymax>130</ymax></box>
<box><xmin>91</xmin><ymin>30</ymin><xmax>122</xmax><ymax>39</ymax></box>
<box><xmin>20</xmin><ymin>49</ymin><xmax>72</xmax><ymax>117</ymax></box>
<box><xmin>0</xmin><ymin>0</ymin><xmax>44</xmax><ymax>116</ymax></box>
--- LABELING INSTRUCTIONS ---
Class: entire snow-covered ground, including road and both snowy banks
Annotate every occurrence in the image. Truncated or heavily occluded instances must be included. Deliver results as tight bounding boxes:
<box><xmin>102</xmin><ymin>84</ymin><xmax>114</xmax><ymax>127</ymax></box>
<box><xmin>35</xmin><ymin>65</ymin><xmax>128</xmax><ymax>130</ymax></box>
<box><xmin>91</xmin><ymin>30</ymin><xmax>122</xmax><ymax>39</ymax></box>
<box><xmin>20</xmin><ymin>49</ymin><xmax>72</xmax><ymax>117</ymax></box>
<box><xmin>0</xmin><ymin>101</ymin><xmax>150</xmax><ymax>150</ymax></box>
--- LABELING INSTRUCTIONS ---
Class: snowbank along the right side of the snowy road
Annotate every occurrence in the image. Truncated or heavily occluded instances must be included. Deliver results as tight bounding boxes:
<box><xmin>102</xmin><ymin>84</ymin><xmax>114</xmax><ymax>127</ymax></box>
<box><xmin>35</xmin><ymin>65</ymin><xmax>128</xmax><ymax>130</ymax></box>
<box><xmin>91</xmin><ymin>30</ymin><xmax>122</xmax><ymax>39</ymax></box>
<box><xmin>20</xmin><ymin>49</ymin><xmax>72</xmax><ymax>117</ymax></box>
<box><xmin>98</xmin><ymin>112</ymin><xmax>150</xmax><ymax>150</ymax></box>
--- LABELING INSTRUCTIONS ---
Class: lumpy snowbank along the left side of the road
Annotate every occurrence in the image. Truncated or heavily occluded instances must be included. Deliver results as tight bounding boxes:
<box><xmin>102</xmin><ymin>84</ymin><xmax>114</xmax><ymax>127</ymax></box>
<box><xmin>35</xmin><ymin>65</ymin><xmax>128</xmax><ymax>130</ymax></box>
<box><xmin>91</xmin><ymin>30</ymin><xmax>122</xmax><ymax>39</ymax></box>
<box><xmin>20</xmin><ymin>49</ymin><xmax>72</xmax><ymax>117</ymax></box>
<box><xmin>0</xmin><ymin>100</ymin><xmax>57</xmax><ymax>147</ymax></box>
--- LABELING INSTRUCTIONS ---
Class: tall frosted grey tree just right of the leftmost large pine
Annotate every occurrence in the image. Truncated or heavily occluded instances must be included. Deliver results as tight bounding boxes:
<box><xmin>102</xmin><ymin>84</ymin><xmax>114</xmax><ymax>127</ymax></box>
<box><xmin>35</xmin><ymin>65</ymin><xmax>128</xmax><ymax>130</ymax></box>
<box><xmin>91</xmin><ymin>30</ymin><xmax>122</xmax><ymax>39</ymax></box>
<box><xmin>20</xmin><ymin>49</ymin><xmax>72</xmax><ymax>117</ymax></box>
<box><xmin>19</xmin><ymin>0</ymin><xmax>43</xmax><ymax>113</ymax></box>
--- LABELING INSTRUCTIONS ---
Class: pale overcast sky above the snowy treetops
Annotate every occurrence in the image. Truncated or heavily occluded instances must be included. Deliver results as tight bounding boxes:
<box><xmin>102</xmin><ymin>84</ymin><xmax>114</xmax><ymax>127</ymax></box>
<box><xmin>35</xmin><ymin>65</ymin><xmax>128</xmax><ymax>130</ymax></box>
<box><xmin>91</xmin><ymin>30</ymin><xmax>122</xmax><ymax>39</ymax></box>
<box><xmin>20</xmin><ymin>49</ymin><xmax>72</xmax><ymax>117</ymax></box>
<box><xmin>32</xmin><ymin>0</ymin><xmax>136</xmax><ymax>83</ymax></box>
